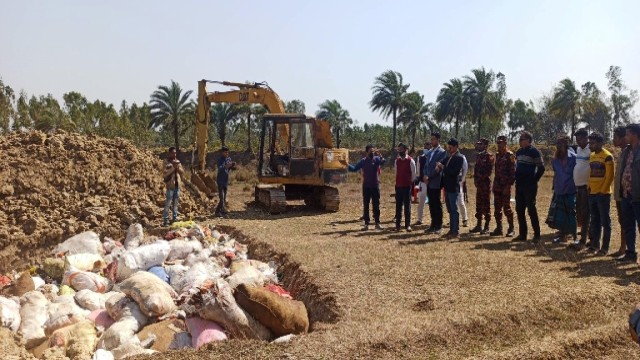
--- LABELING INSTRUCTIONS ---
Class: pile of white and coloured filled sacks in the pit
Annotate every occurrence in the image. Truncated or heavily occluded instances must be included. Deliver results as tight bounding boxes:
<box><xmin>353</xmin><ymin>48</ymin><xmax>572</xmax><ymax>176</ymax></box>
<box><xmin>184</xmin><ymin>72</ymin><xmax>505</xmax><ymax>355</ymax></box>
<box><xmin>0</xmin><ymin>222</ymin><xmax>309</xmax><ymax>360</ymax></box>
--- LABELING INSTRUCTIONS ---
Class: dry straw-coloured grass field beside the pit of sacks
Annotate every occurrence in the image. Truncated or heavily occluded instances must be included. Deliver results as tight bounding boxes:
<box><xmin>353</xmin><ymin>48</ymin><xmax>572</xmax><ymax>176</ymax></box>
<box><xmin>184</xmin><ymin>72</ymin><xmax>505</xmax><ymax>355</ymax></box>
<box><xmin>148</xmin><ymin>175</ymin><xmax>640</xmax><ymax>360</ymax></box>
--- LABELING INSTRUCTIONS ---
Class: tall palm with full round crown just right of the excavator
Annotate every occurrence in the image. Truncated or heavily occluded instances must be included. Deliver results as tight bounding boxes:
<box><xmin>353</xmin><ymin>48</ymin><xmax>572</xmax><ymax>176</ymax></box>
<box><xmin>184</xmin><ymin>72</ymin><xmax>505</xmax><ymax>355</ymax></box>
<box><xmin>369</xmin><ymin>70</ymin><xmax>409</xmax><ymax>149</ymax></box>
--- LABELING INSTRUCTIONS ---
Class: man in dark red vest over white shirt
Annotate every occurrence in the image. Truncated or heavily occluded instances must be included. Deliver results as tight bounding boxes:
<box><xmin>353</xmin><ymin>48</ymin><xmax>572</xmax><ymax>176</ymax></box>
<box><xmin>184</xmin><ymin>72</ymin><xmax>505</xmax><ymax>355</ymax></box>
<box><xmin>395</xmin><ymin>143</ymin><xmax>417</xmax><ymax>232</ymax></box>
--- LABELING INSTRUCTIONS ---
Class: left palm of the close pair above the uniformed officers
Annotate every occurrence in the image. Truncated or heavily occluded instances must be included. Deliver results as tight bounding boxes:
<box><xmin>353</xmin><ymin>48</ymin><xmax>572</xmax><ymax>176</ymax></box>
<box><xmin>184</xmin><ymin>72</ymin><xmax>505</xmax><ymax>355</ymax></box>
<box><xmin>436</xmin><ymin>79</ymin><xmax>471</xmax><ymax>138</ymax></box>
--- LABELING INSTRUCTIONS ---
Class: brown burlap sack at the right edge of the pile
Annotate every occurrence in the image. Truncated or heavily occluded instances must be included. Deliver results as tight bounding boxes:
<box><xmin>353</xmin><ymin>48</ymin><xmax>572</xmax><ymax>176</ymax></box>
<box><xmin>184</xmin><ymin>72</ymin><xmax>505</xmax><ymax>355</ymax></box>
<box><xmin>234</xmin><ymin>284</ymin><xmax>309</xmax><ymax>337</ymax></box>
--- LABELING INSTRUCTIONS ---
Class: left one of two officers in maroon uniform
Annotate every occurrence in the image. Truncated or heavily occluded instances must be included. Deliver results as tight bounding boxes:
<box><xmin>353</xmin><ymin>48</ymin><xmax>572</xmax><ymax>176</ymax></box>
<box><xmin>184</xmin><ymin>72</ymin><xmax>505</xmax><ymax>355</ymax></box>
<box><xmin>469</xmin><ymin>138</ymin><xmax>495</xmax><ymax>235</ymax></box>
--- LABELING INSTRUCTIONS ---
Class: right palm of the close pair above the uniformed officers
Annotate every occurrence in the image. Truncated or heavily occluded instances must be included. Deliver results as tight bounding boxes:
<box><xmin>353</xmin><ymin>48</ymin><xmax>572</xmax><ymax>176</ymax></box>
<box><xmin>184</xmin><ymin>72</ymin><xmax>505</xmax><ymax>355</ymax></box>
<box><xmin>464</xmin><ymin>67</ymin><xmax>501</xmax><ymax>139</ymax></box>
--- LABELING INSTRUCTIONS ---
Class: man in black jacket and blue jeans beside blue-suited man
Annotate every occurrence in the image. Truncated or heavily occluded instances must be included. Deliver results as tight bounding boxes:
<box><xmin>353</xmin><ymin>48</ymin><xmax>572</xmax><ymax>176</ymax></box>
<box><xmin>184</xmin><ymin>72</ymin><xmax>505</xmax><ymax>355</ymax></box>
<box><xmin>436</xmin><ymin>138</ymin><xmax>464</xmax><ymax>239</ymax></box>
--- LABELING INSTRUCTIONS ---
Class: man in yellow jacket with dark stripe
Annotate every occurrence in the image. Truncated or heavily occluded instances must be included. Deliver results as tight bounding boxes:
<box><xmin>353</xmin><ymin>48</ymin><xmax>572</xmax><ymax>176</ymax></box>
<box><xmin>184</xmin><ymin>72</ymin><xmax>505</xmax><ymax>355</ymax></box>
<box><xmin>588</xmin><ymin>132</ymin><xmax>614</xmax><ymax>255</ymax></box>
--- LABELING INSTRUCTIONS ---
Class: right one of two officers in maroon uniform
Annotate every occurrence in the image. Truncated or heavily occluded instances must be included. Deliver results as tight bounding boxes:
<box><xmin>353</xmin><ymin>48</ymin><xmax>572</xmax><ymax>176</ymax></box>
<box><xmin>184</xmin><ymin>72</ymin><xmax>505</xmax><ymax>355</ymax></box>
<box><xmin>490</xmin><ymin>136</ymin><xmax>516</xmax><ymax>236</ymax></box>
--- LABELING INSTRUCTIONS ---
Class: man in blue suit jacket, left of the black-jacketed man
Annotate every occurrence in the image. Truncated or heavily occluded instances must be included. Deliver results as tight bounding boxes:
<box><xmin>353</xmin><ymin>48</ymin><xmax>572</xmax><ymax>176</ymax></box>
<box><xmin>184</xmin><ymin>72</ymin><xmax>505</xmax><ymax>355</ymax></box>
<box><xmin>422</xmin><ymin>132</ymin><xmax>447</xmax><ymax>234</ymax></box>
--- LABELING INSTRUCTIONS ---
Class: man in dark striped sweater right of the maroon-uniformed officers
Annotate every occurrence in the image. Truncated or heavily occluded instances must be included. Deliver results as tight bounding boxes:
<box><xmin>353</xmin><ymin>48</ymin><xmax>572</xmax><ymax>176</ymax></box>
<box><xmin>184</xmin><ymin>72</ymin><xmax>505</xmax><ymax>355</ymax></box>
<box><xmin>513</xmin><ymin>131</ymin><xmax>544</xmax><ymax>243</ymax></box>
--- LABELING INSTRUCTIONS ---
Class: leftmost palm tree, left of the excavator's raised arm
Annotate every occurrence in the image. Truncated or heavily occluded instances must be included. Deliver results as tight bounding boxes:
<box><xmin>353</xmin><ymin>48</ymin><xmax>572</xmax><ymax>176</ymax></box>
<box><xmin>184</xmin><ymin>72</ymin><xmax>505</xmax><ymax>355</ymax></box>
<box><xmin>149</xmin><ymin>80</ymin><xmax>195</xmax><ymax>151</ymax></box>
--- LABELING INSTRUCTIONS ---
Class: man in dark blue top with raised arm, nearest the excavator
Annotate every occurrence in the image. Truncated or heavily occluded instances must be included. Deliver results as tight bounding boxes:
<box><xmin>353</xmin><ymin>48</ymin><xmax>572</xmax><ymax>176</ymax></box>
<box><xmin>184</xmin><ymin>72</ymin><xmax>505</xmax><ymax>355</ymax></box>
<box><xmin>349</xmin><ymin>145</ymin><xmax>385</xmax><ymax>231</ymax></box>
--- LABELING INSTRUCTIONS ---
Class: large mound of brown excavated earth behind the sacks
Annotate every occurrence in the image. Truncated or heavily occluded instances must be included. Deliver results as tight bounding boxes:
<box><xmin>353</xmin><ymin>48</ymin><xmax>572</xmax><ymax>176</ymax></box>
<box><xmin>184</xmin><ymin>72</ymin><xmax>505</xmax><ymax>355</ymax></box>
<box><xmin>0</xmin><ymin>131</ymin><xmax>211</xmax><ymax>273</ymax></box>
